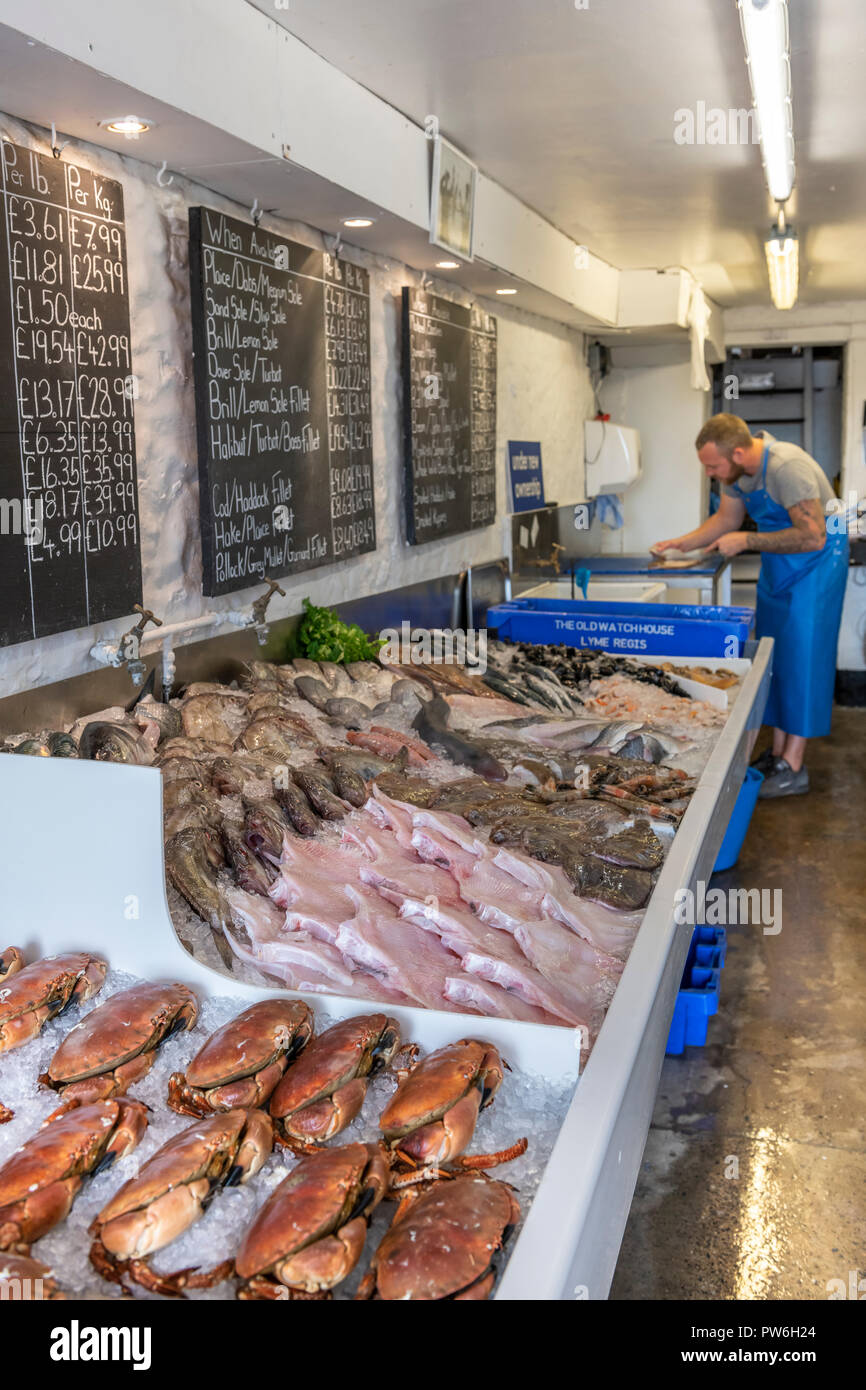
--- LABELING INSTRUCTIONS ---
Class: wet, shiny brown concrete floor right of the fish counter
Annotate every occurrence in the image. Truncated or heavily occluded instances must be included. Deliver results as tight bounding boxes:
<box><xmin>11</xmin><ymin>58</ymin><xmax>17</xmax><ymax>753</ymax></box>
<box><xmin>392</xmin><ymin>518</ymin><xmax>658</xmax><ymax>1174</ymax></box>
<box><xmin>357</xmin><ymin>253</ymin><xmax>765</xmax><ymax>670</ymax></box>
<box><xmin>610</xmin><ymin>708</ymin><xmax>866</xmax><ymax>1300</ymax></box>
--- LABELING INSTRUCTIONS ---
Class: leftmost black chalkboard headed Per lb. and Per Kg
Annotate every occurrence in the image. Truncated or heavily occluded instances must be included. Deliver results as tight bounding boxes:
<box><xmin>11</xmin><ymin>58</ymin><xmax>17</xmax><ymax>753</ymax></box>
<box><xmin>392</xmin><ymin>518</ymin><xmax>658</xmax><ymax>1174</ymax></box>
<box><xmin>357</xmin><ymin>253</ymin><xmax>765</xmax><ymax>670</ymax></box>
<box><xmin>0</xmin><ymin>140</ymin><xmax>142</xmax><ymax>645</ymax></box>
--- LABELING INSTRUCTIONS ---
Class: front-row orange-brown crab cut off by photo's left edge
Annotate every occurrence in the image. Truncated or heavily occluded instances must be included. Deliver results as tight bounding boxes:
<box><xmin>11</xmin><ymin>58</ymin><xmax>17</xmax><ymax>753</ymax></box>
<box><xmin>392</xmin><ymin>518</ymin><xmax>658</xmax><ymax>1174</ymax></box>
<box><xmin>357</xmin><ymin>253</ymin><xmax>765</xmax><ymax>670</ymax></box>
<box><xmin>0</xmin><ymin>1098</ymin><xmax>147</xmax><ymax>1250</ymax></box>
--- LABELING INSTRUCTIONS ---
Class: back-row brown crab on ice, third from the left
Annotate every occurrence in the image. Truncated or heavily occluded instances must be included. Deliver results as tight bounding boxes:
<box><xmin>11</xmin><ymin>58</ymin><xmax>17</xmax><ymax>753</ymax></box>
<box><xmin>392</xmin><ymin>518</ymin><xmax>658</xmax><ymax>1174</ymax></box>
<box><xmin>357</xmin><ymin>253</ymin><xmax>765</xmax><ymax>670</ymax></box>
<box><xmin>168</xmin><ymin>998</ymin><xmax>313</xmax><ymax>1115</ymax></box>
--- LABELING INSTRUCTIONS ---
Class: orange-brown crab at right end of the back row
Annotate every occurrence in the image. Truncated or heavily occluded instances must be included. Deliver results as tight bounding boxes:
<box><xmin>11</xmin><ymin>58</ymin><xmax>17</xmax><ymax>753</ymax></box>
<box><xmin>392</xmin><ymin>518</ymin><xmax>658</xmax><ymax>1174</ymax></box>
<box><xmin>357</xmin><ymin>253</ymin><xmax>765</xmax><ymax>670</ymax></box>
<box><xmin>379</xmin><ymin>1038</ymin><xmax>503</xmax><ymax>1163</ymax></box>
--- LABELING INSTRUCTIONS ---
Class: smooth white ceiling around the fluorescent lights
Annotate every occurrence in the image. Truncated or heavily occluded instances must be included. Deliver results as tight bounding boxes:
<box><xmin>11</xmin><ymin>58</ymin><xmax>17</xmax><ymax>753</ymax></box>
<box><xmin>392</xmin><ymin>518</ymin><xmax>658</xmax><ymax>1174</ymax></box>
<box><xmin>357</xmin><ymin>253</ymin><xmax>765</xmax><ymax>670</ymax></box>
<box><xmin>250</xmin><ymin>0</ymin><xmax>866</xmax><ymax>304</ymax></box>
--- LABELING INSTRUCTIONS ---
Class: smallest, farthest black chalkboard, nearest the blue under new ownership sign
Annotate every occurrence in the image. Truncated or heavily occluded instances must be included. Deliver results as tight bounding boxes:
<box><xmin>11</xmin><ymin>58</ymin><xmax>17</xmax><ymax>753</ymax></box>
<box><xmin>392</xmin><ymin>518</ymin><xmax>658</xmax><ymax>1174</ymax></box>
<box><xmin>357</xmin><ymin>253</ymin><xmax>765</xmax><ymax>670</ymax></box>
<box><xmin>403</xmin><ymin>288</ymin><xmax>496</xmax><ymax>545</ymax></box>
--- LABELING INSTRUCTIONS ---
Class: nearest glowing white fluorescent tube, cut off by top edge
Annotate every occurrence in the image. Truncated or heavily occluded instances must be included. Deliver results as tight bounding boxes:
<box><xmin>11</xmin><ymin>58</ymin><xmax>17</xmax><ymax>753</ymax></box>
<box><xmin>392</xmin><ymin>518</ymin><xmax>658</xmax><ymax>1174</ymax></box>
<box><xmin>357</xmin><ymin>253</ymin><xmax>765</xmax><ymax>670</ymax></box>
<box><xmin>738</xmin><ymin>0</ymin><xmax>794</xmax><ymax>203</ymax></box>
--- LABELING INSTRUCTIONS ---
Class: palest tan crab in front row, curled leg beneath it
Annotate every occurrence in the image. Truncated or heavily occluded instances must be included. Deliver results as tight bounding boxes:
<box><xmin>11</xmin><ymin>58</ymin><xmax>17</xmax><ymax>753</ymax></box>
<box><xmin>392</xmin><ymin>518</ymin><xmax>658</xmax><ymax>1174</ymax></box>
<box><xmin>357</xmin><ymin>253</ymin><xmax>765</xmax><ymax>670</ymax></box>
<box><xmin>89</xmin><ymin>1109</ymin><xmax>274</xmax><ymax>1297</ymax></box>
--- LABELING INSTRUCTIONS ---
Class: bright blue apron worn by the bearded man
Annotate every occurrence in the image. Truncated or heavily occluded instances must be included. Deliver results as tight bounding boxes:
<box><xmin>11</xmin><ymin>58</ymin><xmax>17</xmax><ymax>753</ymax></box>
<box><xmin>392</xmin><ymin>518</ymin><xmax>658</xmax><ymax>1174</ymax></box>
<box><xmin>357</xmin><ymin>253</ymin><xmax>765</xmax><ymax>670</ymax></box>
<box><xmin>734</xmin><ymin>443</ymin><xmax>848</xmax><ymax>738</ymax></box>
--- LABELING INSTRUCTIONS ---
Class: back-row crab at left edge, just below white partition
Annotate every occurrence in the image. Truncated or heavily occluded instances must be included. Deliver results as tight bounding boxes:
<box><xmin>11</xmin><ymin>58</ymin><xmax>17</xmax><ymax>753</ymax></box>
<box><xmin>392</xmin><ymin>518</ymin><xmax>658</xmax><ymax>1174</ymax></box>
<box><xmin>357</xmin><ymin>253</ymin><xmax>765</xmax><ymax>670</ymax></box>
<box><xmin>0</xmin><ymin>947</ymin><xmax>108</xmax><ymax>1052</ymax></box>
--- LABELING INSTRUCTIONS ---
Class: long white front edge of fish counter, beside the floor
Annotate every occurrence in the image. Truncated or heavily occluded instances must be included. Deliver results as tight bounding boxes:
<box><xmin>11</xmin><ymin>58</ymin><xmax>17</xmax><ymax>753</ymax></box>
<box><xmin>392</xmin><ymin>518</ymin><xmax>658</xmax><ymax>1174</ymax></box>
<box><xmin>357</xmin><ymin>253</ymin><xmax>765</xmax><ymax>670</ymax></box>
<box><xmin>496</xmin><ymin>638</ymin><xmax>773</xmax><ymax>1300</ymax></box>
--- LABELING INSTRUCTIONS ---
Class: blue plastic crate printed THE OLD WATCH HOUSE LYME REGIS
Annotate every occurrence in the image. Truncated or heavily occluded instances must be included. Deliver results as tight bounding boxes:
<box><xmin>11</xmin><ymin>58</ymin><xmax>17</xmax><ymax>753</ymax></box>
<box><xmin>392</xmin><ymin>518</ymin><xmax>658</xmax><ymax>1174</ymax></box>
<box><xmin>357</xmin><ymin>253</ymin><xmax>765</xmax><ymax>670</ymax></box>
<box><xmin>487</xmin><ymin>599</ymin><xmax>755</xmax><ymax>657</ymax></box>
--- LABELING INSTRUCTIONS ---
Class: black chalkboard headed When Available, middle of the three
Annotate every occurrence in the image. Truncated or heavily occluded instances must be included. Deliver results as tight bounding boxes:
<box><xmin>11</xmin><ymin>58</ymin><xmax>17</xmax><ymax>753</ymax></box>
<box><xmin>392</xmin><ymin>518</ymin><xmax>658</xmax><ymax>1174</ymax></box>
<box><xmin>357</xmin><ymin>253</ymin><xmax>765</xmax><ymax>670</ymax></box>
<box><xmin>189</xmin><ymin>207</ymin><xmax>375</xmax><ymax>594</ymax></box>
